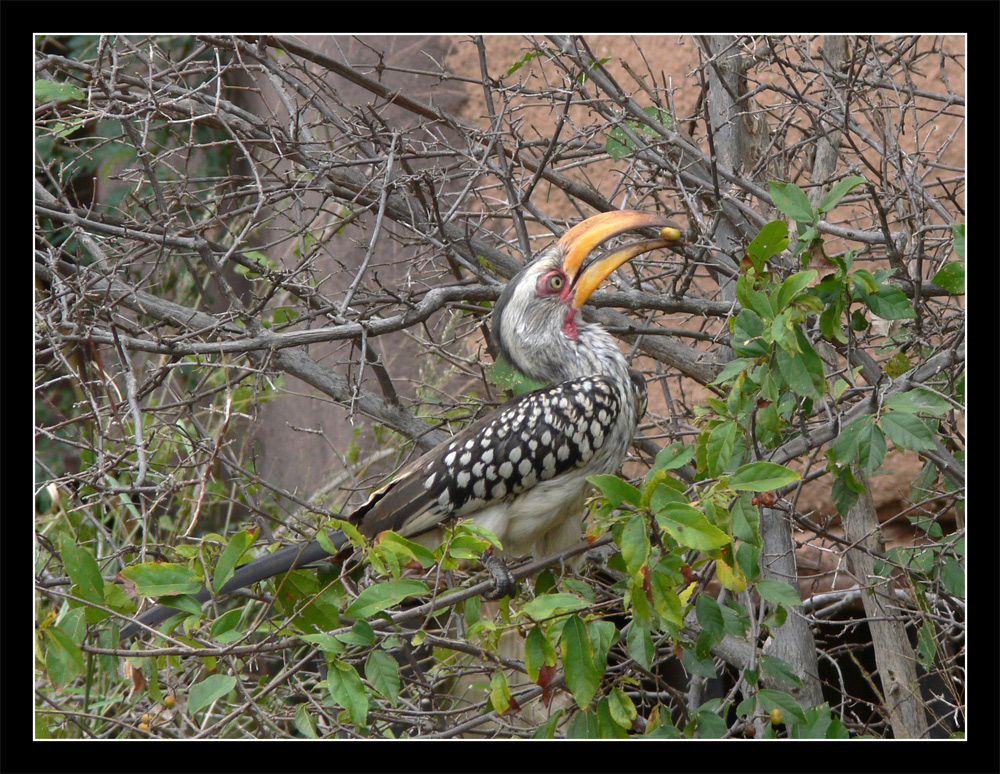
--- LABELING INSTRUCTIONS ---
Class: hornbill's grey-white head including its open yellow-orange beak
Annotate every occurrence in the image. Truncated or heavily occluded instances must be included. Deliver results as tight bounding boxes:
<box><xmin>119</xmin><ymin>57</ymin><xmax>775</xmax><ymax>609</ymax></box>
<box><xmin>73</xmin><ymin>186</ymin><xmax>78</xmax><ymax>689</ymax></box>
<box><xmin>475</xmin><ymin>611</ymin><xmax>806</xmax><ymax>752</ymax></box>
<box><xmin>491</xmin><ymin>210</ymin><xmax>681</xmax><ymax>384</ymax></box>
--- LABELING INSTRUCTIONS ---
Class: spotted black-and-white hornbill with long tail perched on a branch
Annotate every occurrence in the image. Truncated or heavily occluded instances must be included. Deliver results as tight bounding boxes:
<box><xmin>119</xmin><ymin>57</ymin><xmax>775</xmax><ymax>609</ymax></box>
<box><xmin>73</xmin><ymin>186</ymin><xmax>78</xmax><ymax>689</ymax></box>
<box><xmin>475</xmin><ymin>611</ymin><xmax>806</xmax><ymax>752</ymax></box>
<box><xmin>120</xmin><ymin>210</ymin><xmax>681</xmax><ymax>641</ymax></box>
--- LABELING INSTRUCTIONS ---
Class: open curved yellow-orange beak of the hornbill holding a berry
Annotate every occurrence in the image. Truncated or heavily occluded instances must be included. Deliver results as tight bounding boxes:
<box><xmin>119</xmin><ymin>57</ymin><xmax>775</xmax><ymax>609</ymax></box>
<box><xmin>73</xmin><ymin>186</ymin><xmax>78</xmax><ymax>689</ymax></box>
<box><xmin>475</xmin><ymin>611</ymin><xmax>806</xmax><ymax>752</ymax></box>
<box><xmin>559</xmin><ymin>210</ymin><xmax>681</xmax><ymax>309</ymax></box>
